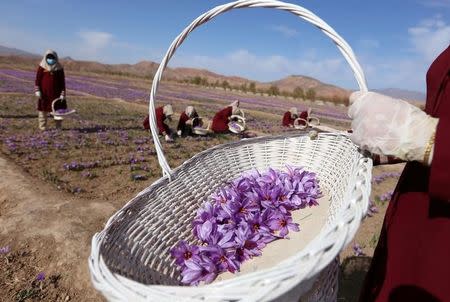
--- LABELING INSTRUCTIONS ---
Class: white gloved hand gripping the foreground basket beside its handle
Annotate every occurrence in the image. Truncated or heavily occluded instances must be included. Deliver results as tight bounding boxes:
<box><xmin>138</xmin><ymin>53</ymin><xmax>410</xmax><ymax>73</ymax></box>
<box><xmin>348</xmin><ymin>91</ymin><xmax>439</xmax><ymax>164</ymax></box>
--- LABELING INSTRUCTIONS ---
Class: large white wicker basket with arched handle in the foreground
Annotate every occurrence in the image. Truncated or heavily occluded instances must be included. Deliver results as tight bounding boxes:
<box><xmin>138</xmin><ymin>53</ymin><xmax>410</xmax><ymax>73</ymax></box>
<box><xmin>89</xmin><ymin>0</ymin><xmax>372</xmax><ymax>301</ymax></box>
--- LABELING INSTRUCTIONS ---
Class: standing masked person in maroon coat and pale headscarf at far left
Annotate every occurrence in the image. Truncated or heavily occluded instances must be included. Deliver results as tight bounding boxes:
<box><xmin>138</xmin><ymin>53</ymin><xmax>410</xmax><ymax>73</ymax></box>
<box><xmin>34</xmin><ymin>49</ymin><xmax>66</xmax><ymax>130</ymax></box>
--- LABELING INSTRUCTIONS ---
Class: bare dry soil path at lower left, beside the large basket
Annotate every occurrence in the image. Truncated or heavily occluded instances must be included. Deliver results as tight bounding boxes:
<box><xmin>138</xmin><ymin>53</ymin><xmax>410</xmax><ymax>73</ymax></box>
<box><xmin>0</xmin><ymin>157</ymin><xmax>116</xmax><ymax>301</ymax></box>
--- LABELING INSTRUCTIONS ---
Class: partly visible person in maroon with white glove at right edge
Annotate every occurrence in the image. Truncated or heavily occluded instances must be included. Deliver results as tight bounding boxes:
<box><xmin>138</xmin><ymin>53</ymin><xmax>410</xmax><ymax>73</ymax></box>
<box><xmin>349</xmin><ymin>47</ymin><xmax>450</xmax><ymax>302</ymax></box>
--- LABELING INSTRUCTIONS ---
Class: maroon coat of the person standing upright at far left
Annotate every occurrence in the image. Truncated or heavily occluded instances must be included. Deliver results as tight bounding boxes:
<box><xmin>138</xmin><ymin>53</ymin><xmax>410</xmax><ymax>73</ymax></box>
<box><xmin>35</xmin><ymin>66</ymin><xmax>66</xmax><ymax>112</ymax></box>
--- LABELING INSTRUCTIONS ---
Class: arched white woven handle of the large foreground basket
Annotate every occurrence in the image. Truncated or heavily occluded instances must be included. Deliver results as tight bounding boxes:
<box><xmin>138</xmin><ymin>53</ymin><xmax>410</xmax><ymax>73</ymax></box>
<box><xmin>149</xmin><ymin>0</ymin><xmax>367</xmax><ymax>177</ymax></box>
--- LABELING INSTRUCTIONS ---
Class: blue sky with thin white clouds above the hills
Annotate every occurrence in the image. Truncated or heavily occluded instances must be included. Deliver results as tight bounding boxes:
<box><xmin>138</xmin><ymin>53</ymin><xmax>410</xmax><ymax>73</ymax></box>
<box><xmin>0</xmin><ymin>0</ymin><xmax>450</xmax><ymax>91</ymax></box>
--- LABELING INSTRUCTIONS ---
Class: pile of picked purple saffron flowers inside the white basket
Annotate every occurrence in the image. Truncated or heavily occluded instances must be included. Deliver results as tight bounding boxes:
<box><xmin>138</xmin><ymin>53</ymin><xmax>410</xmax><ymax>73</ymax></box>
<box><xmin>171</xmin><ymin>166</ymin><xmax>322</xmax><ymax>285</ymax></box>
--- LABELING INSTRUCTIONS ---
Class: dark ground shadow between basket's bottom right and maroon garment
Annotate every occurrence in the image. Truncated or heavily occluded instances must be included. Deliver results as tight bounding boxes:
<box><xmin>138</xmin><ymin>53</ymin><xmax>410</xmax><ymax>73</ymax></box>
<box><xmin>338</xmin><ymin>256</ymin><xmax>372</xmax><ymax>302</ymax></box>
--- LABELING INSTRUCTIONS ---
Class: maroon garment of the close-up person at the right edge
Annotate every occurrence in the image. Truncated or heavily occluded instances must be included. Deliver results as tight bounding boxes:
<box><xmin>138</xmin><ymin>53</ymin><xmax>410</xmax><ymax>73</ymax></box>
<box><xmin>360</xmin><ymin>47</ymin><xmax>450</xmax><ymax>302</ymax></box>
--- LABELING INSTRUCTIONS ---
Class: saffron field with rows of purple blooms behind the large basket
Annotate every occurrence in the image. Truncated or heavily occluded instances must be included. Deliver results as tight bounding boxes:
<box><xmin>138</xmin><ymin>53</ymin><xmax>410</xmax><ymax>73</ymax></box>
<box><xmin>0</xmin><ymin>68</ymin><xmax>403</xmax><ymax>301</ymax></box>
